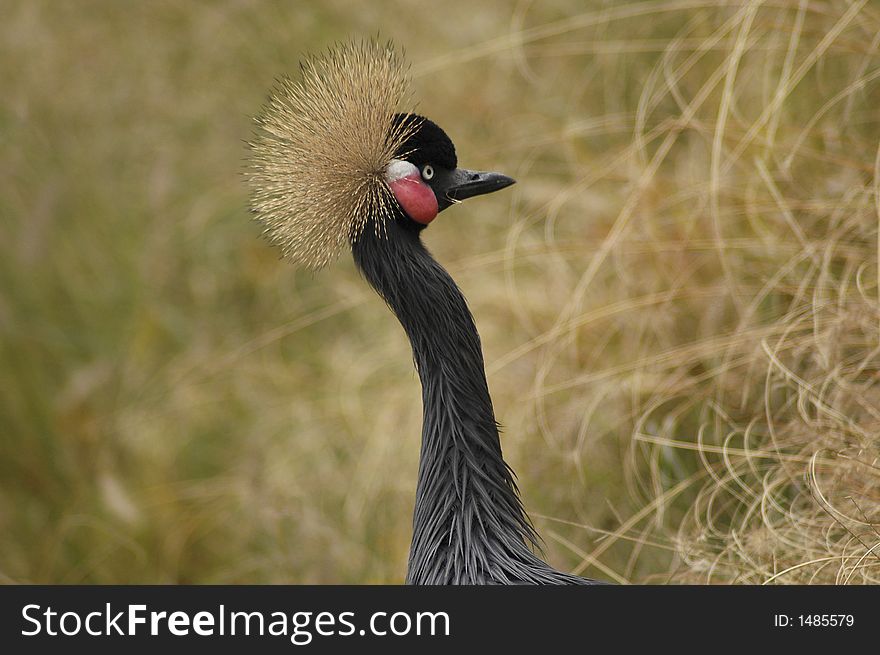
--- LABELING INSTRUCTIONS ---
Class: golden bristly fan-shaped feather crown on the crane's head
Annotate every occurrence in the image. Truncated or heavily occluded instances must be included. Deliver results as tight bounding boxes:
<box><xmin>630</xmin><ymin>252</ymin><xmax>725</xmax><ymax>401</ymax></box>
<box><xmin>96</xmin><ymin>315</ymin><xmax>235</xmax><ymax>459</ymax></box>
<box><xmin>247</xmin><ymin>41</ymin><xmax>418</xmax><ymax>270</ymax></box>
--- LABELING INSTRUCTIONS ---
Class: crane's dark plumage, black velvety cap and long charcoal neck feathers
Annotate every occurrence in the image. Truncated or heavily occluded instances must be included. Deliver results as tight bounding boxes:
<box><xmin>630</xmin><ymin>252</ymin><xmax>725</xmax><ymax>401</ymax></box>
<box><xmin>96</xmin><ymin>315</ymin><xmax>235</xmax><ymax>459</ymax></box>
<box><xmin>352</xmin><ymin>116</ymin><xmax>592</xmax><ymax>584</ymax></box>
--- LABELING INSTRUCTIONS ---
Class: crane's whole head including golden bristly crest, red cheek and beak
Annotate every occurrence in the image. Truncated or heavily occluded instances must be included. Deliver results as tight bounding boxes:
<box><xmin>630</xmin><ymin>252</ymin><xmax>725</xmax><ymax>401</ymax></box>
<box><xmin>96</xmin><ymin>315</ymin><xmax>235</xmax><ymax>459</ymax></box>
<box><xmin>247</xmin><ymin>41</ymin><xmax>513</xmax><ymax>269</ymax></box>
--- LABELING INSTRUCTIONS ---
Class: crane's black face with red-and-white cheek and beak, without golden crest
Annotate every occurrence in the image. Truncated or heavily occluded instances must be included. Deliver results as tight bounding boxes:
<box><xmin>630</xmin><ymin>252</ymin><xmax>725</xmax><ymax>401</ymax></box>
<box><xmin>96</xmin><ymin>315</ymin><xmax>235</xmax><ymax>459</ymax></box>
<box><xmin>385</xmin><ymin>114</ymin><xmax>514</xmax><ymax>227</ymax></box>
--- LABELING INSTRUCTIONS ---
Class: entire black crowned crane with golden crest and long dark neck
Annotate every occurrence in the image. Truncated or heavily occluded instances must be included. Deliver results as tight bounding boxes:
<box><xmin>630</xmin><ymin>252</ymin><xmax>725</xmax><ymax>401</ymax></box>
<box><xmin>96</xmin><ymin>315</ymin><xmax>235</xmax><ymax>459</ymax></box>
<box><xmin>248</xmin><ymin>42</ymin><xmax>593</xmax><ymax>584</ymax></box>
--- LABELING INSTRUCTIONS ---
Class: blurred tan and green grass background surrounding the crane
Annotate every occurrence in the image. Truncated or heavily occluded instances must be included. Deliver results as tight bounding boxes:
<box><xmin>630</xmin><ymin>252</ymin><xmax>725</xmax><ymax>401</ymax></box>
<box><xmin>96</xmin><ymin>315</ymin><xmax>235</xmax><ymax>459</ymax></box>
<box><xmin>0</xmin><ymin>0</ymin><xmax>880</xmax><ymax>583</ymax></box>
